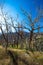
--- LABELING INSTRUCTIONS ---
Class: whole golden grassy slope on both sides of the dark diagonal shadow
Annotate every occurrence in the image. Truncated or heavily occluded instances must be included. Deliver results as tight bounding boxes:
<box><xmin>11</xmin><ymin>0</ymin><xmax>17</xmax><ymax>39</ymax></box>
<box><xmin>0</xmin><ymin>47</ymin><xmax>43</xmax><ymax>65</ymax></box>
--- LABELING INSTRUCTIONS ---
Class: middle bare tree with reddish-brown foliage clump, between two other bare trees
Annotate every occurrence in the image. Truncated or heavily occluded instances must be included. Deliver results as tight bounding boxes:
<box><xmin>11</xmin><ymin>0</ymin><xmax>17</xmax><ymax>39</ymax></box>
<box><xmin>10</xmin><ymin>17</ymin><xmax>23</xmax><ymax>48</ymax></box>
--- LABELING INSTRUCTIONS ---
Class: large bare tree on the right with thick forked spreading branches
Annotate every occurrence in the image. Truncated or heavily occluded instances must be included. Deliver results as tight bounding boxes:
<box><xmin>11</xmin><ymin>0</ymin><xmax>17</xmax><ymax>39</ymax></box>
<box><xmin>21</xmin><ymin>9</ymin><xmax>43</xmax><ymax>50</ymax></box>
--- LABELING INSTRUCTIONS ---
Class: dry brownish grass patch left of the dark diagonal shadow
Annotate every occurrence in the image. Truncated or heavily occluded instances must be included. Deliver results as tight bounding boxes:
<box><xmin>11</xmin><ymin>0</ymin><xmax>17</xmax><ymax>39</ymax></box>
<box><xmin>0</xmin><ymin>47</ymin><xmax>10</xmax><ymax>65</ymax></box>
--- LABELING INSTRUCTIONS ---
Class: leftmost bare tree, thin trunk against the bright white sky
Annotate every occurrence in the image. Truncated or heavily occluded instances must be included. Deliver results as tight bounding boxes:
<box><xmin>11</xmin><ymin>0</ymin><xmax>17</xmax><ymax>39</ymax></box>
<box><xmin>0</xmin><ymin>8</ymin><xmax>9</xmax><ymax>51</ymax></box>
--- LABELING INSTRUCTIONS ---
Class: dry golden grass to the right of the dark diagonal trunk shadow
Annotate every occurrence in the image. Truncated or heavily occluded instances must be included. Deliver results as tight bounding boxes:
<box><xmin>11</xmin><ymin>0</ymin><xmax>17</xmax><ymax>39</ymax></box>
<box><xmin>10</xmin><ymin>49</ymin><xmax>43</xmax><ymax>65</ymax></box>
